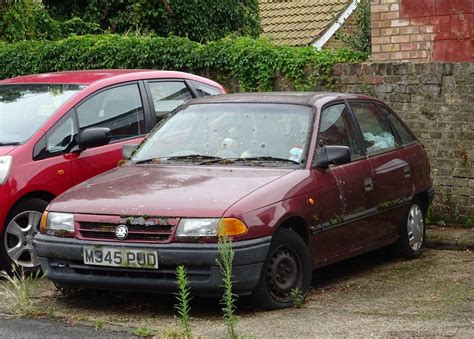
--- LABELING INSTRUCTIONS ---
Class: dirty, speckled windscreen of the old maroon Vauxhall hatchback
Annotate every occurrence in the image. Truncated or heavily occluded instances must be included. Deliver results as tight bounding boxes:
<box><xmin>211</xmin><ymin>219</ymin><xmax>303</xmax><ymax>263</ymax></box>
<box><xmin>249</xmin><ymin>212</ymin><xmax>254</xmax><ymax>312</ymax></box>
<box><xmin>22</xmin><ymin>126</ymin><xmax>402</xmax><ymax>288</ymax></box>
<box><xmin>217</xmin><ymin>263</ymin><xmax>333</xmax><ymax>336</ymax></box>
<box><xmin>132</xmin><ymin>103</ymin><xmax>313</xmax><ymax>166</ymax></box>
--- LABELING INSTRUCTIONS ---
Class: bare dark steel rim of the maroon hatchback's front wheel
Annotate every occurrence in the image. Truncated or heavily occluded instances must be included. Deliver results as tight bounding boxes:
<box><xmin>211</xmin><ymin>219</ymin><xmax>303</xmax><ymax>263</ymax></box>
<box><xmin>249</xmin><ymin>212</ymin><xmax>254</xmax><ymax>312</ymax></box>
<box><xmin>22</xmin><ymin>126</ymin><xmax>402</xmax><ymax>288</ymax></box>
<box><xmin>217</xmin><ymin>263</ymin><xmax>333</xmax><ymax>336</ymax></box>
<box><xmin>267</xmin><ymin>248</ymin><xmax>303</xmax><ymax>302</ymax></box>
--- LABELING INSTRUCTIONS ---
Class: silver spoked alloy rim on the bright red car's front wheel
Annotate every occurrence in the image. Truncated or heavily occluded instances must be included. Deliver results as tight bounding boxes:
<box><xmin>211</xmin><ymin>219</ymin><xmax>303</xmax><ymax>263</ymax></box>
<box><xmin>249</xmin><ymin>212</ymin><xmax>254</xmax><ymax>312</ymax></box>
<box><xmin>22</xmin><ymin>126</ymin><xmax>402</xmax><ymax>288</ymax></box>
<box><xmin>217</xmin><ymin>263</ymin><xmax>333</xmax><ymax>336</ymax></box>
<box><xmin>4</xmin><ymin>211</ymin><xmax>41</xmax><ymax>267</ymax></box>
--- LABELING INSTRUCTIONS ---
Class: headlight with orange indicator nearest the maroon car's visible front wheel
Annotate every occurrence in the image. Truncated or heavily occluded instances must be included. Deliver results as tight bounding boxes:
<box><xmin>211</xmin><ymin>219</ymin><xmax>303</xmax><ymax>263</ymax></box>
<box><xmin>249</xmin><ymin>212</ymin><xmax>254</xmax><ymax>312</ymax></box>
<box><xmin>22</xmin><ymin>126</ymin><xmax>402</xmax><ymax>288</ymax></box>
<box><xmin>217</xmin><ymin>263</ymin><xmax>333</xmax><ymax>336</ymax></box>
<box><xmin>176</xmin><ymin>218</ymin><xmax>247</xmax><ymax>237</ymax></box>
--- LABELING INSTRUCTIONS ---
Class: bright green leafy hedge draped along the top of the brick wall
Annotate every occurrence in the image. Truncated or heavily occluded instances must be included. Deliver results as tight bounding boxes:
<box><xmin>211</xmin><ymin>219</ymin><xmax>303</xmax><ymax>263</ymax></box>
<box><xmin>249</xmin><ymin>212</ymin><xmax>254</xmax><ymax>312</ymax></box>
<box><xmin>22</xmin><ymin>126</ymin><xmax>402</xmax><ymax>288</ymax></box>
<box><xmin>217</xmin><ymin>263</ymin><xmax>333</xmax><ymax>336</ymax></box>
<box><xmin>0</xmin><ymin>35</ymin><xmax>365</xmax><ymax>91</ymax></box>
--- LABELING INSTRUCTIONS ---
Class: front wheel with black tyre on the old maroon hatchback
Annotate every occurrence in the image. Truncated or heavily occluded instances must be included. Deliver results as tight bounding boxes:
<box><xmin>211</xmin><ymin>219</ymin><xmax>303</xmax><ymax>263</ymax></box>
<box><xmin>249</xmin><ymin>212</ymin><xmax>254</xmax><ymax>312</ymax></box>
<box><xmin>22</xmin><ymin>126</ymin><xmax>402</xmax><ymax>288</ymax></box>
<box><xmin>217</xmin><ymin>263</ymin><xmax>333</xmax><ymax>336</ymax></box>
<box><xmin>252</xmin><ymin>228</ymin><xmax>311</xmax><ymax>309</ymax></box>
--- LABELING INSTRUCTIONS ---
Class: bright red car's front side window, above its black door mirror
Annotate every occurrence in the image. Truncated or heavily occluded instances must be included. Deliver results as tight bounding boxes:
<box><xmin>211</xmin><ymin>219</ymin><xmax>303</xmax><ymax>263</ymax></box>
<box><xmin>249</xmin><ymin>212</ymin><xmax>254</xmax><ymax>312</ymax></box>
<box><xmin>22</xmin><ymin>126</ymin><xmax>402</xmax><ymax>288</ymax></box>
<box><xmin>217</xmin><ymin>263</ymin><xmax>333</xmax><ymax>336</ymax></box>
<box><xmin>77</xmin><ymin>84</ymin><xmax>145</xmax><ymax>140</ymax></box>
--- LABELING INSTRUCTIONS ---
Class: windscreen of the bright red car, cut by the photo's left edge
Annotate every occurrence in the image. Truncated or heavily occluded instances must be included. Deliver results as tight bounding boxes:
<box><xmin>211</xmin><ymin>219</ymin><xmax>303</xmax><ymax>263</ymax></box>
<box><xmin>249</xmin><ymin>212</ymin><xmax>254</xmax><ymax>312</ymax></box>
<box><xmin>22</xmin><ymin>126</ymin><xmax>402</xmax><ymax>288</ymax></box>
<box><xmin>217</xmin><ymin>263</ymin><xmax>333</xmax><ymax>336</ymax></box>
<box><xmin>0</xmin><ymin>84</ymin><xmax>84</xmax><ymax>146</ymax></box>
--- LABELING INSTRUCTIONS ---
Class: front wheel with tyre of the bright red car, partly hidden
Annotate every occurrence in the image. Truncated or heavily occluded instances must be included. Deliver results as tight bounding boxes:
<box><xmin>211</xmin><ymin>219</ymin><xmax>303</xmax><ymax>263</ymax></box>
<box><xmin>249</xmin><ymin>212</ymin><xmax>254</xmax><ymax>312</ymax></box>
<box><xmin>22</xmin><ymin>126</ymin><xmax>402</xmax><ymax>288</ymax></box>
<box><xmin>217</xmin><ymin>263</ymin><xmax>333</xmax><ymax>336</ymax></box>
<box><xmin>0</xmin><ymin>198</ymin><xmax>48</xmax><ymax>272</ymax></box>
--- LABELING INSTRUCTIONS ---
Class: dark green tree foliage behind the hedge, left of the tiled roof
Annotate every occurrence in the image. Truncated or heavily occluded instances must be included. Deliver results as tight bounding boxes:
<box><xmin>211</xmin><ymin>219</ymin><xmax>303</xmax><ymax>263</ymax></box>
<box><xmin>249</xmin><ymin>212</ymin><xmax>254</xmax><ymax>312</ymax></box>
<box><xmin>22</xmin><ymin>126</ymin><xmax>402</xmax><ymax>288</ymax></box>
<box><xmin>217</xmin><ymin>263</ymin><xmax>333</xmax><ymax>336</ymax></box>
<box><xmin>43</xmin><ymin>0</ymin><xmax>260</xmax><ymax>42</ymax></box>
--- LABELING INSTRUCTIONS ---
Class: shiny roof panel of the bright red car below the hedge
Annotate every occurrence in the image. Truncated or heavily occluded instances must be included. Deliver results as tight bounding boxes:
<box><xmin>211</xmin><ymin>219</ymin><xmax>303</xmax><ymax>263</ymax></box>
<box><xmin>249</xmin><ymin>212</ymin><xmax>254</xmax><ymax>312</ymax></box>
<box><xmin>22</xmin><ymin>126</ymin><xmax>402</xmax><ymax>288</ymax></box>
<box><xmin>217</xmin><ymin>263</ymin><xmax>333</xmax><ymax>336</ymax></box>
<box><xmin>0</xmin><ymin>69</ymin><xmax>222</xmax><ymax>85</ymax></box>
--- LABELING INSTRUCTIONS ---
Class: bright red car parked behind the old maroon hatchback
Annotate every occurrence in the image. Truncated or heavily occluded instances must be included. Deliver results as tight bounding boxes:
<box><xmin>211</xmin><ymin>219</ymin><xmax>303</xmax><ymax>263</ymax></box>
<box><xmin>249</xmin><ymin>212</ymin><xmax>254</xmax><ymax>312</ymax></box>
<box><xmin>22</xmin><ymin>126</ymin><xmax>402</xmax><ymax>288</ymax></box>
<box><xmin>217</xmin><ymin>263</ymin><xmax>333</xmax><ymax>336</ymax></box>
<box><xmin>0</xmin><ymin>70</ymin><xmax>225</xmax><ymax>270</ymax></box>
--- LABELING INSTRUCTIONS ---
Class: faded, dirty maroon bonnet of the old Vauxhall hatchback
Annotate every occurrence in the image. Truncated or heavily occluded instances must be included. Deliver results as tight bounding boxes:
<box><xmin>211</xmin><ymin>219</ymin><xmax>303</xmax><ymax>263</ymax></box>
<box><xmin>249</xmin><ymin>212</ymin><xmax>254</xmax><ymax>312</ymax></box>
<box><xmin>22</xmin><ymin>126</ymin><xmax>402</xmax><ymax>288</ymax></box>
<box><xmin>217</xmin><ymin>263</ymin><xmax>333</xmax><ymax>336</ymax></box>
<box><xmin>49</xmin><ymin>165</ymin><xmax>293</xmax><ymax>217</ymax></box>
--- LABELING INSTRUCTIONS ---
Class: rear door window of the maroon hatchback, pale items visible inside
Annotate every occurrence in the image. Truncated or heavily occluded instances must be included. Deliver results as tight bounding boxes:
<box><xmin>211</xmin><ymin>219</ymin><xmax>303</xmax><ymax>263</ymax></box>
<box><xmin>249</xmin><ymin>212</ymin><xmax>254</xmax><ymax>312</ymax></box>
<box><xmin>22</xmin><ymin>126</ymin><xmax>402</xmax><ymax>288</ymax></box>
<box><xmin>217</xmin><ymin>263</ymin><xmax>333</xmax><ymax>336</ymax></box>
<box><xmin>349</xmin><ymin>101</ymin><xmax>398</xmax><ymax>156</ymax></box>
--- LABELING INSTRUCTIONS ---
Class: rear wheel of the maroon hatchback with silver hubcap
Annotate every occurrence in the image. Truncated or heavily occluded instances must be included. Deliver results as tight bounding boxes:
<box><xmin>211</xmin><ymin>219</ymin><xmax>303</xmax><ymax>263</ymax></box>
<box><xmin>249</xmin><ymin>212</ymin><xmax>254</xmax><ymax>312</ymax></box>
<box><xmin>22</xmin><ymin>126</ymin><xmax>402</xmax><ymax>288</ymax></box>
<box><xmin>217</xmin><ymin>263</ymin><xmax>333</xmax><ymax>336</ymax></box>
<box><xmin>397</xmin><ymin>199</ymin><xmax>426</xmax><ymax>258</ymax></box>
